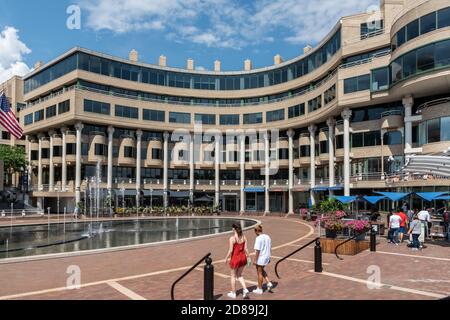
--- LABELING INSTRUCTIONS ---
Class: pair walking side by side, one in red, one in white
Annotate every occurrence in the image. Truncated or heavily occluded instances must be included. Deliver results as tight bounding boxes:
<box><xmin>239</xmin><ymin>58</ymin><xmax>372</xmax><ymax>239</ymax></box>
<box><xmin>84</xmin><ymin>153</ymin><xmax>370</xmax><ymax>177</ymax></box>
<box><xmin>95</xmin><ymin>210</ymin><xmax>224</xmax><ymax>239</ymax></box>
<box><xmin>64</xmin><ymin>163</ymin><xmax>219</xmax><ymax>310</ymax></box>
<box><xmin>225</xmin><ymin>224</ymin><xmax>273</xmax><ymax>299</ymax></box>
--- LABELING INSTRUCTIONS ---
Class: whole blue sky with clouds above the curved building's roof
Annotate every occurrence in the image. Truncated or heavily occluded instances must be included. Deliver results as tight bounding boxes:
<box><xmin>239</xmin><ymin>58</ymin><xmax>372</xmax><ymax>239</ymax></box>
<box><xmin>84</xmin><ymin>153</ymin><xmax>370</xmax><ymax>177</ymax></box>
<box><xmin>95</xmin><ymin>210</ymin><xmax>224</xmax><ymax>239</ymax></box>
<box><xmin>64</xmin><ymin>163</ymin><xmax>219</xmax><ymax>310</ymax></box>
<box><xmin>0</xmin><ymin>0</ymin><xmax>379</xmax><ymax>83</ymax></box>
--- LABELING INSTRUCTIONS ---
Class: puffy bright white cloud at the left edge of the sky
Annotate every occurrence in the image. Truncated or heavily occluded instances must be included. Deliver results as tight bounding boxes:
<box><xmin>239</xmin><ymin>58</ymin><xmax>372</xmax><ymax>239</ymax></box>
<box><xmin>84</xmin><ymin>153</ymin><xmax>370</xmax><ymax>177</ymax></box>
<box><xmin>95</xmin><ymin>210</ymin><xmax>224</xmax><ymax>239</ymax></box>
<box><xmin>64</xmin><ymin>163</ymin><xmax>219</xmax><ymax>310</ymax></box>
<box><xmin>0</xmin><ymin>26</ymin><xmax>31</xmax><ymax>83</ymax></box>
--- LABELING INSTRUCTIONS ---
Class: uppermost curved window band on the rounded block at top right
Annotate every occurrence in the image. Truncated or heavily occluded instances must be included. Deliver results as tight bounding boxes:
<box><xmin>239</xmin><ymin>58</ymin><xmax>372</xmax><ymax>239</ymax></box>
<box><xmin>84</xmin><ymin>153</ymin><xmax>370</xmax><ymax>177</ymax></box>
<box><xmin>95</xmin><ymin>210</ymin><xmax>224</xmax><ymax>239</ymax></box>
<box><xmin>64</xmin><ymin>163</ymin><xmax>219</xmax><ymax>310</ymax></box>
<box><xmin>391</xmin><ymin>7</ymin><xmax>450</xmax><ymax>51</ymax></box>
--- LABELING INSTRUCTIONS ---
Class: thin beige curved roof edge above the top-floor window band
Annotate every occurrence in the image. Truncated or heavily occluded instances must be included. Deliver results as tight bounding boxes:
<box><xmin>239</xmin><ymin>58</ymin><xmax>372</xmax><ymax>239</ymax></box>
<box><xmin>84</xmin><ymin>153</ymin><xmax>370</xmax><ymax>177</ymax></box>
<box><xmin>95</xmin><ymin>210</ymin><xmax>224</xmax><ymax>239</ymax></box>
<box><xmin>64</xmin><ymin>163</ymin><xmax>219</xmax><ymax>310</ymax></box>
<box><xmin>23</xmin><ymin>19</ymin><xmax>342</xmax><ymax>80</ymax></box>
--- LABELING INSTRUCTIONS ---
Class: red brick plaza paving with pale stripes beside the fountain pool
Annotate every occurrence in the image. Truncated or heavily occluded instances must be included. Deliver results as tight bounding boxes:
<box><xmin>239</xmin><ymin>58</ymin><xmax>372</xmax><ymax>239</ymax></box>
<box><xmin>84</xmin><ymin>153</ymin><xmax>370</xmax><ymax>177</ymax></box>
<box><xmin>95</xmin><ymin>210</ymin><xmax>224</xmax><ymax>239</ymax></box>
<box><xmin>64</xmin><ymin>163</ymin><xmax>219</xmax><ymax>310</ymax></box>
<box><xmin>0</xmin><ymin>217</ymin><xmax>450</xmax><ymax>300</ymax></box>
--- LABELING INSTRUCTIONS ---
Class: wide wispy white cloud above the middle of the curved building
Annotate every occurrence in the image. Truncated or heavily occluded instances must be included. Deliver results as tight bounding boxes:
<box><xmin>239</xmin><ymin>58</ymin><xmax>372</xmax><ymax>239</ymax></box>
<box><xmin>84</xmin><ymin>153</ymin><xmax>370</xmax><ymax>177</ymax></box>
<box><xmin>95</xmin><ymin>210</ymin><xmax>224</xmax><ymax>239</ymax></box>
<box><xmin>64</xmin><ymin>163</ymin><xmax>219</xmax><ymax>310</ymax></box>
<box><xmin>80</xmin><ymin>0</ymin><xmax>379</xmax><ymax>49</ymax></box>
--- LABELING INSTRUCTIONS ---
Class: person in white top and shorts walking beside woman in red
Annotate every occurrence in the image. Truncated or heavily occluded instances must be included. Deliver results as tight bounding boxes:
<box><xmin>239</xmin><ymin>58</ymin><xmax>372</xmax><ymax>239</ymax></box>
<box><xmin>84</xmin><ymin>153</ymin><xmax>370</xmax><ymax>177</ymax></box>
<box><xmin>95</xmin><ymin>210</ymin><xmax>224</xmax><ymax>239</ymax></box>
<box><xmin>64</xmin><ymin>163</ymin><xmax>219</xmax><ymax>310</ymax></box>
<box><xmin>253</xmin><ymin>225</ymin><xmax>273</xmax><ymax>294</ymax></box>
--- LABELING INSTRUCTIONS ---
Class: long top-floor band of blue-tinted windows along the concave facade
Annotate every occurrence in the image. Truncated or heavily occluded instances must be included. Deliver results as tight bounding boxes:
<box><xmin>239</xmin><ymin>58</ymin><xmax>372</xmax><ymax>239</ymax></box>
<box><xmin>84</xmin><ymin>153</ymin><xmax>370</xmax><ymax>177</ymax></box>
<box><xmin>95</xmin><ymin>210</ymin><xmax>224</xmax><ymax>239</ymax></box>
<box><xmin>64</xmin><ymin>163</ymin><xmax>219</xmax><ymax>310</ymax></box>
<box><xmin>24</xmin><ymin>30</ymin><xmax>341</xmax><ymax>93</ymax></box>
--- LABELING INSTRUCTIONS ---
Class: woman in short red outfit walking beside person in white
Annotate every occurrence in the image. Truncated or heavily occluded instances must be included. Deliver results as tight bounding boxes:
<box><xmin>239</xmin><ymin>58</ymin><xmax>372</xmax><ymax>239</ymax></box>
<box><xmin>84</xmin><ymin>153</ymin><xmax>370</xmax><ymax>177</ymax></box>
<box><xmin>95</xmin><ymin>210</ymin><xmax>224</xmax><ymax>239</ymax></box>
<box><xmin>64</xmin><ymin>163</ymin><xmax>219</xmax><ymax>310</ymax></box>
<box><xmin>225</xmin><ymin>224</ymin><xmax>248</xmax><ymax>299</ymax></box>
